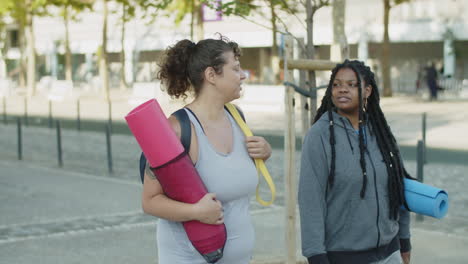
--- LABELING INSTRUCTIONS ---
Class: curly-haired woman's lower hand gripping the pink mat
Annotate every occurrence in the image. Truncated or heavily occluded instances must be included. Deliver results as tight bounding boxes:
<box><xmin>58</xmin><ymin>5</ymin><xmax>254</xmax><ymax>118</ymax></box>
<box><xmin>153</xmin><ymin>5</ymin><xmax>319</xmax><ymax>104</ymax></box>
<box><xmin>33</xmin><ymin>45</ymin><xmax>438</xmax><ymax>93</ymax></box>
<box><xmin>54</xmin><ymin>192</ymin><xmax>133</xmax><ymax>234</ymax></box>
<box><xmin>194</xmin><ymin>193</ymin><xmax>224</xmax><ymax>225</ymax></box>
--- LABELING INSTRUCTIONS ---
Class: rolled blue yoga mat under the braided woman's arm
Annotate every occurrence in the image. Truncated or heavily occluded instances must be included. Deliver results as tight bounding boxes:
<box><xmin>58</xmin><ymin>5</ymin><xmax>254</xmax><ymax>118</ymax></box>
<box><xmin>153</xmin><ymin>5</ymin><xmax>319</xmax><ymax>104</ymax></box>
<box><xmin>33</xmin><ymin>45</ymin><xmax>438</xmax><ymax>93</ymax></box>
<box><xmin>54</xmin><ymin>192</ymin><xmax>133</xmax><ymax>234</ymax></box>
<box><xmin>404</xmin><ymin>179</ymin><xmax>449</xmax><ymax>219</ymax></box>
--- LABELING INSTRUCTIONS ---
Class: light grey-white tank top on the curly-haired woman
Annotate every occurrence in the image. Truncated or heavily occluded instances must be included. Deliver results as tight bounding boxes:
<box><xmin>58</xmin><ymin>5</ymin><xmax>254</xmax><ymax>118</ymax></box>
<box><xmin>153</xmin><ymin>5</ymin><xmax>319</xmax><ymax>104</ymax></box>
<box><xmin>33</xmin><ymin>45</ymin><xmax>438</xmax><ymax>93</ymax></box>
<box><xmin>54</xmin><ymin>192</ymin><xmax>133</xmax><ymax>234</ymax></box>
<box><xmin>158</xmin><ymin>109</ymin><xmax>258</xmax><ymax>264</ymax></box>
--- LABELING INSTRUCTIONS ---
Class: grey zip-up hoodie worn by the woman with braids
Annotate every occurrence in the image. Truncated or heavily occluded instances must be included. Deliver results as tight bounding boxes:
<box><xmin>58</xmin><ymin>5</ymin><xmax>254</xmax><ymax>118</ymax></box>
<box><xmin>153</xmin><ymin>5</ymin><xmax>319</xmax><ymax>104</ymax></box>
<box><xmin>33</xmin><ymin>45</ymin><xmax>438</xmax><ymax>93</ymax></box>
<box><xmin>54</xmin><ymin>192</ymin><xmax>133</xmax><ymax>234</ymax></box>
<box><xmin>298</xmin><ymin>112</ymin><xmax>410</xmax><ymax>263</ymax></box>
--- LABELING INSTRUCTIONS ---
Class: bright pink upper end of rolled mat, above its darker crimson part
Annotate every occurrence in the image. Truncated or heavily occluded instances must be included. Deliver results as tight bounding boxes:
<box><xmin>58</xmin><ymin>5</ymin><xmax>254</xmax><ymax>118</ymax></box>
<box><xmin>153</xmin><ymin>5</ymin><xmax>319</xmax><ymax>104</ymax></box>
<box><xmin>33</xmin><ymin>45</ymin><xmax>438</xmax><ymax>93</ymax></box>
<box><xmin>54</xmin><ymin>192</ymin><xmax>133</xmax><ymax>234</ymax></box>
<box><xmin>125</xmin><ymin>99</ymin><xmax>184</xmax><ymax>168</ymax></box>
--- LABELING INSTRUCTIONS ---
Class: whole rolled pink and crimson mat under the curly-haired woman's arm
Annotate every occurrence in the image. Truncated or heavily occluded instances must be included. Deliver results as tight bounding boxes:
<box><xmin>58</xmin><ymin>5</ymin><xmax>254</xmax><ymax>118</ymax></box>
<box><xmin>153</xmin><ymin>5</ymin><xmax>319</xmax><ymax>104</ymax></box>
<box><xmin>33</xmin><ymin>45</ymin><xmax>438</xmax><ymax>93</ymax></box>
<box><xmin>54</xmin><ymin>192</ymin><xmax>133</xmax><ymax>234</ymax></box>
<box><xmin>125</xmin><ymin>99</ymin><xmax>227</xmax><ymax>263</ymax></box>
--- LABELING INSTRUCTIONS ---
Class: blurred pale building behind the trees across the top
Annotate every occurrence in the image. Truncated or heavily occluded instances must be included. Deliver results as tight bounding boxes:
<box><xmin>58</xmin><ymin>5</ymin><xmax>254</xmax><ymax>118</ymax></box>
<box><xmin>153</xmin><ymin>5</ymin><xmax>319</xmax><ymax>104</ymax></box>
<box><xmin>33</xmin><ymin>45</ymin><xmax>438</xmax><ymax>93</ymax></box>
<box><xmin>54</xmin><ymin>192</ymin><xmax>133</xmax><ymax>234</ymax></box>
<box><xmin>0</xmin><ymin>0</ymin><xmax>468</xmax><ymax>92</ymax></box>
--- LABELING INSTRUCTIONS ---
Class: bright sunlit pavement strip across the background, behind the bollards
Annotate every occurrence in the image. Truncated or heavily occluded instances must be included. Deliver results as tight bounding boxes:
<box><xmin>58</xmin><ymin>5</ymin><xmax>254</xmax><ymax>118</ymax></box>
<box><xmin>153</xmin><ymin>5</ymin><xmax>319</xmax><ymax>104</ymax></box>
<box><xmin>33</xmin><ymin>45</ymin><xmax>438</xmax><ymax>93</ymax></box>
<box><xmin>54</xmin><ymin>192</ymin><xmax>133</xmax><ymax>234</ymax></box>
<box><xmin>2</xmin><ymin>85</ymin><xmax>468</xmax><ymax>150</ymax></box>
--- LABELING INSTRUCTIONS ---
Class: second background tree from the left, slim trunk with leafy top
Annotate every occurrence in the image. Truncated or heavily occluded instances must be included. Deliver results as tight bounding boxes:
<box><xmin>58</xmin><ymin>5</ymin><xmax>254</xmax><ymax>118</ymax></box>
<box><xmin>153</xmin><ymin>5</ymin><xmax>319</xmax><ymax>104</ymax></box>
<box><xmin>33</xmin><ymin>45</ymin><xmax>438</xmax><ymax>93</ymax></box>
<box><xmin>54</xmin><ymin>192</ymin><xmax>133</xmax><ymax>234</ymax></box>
<box><xmin>49</xmin><ymin>0</ymin><xmax>94</xmax><ymax>81</ymax></box>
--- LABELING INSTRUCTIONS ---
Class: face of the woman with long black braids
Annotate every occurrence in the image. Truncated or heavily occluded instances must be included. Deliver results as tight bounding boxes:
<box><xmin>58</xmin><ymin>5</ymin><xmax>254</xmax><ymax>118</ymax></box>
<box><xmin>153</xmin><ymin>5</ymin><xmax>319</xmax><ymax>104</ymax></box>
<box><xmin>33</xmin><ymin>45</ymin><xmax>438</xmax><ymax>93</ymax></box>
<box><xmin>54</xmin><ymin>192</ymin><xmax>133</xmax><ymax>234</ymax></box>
<box><xmin>332</xmin><ymin>68</ymin><xmax>372</xmax><ymax>115</ymax></box>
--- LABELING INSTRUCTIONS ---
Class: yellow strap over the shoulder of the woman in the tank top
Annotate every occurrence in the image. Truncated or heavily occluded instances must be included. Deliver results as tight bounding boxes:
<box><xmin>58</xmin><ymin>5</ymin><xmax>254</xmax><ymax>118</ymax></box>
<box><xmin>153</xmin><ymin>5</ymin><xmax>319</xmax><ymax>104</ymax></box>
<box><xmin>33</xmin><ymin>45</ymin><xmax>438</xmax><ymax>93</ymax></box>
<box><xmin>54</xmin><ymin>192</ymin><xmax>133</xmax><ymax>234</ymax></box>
<box><xmin>226</xmin><ymin>104</ymin><xmax>276</xmax><ymax>206</ymax></box>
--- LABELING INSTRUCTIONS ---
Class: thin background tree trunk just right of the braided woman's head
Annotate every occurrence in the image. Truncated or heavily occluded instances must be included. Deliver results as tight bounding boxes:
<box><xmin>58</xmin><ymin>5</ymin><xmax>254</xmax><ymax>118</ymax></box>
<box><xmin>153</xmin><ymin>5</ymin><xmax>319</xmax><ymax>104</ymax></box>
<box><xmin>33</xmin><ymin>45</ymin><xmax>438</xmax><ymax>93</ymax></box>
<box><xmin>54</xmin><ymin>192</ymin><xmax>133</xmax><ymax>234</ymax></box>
<box><xmin>382</xmin><ymin>0</ymin><xmax>392</xmax><ymax>97</ymax></box>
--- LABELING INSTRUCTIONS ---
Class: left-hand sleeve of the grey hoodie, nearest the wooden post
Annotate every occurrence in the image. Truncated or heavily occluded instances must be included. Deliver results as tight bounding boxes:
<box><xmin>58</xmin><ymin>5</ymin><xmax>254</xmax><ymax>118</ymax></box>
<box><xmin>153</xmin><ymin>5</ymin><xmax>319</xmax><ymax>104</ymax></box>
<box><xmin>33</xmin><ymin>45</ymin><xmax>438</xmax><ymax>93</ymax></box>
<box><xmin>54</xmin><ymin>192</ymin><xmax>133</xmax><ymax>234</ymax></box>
<box><xmin>298</xmin><ymin>127</ymin><xmax>329</xmax><ymax>264</ymax></box>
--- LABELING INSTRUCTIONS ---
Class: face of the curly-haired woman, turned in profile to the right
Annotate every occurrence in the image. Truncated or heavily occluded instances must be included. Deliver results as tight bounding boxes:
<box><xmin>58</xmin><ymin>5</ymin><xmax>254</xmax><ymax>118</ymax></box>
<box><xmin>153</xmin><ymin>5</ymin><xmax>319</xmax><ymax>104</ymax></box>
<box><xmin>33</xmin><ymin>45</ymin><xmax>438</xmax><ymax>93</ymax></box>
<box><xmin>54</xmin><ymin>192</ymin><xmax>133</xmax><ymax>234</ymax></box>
<box><xmin>216</xmin><ymin>51</ymin><xmax>246</xmax><ymax>102</ymax></box>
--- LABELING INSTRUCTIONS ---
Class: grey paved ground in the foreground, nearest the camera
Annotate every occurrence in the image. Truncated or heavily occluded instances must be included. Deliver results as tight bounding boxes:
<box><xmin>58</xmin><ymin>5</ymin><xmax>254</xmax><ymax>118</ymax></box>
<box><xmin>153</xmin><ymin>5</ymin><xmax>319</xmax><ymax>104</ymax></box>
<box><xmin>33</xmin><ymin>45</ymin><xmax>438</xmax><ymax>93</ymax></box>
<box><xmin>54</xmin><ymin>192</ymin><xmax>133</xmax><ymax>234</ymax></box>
<box><xmin>0</xmin><ymin>161</ymin><xmax>468</xmax><ymax>264</ymax></box>
